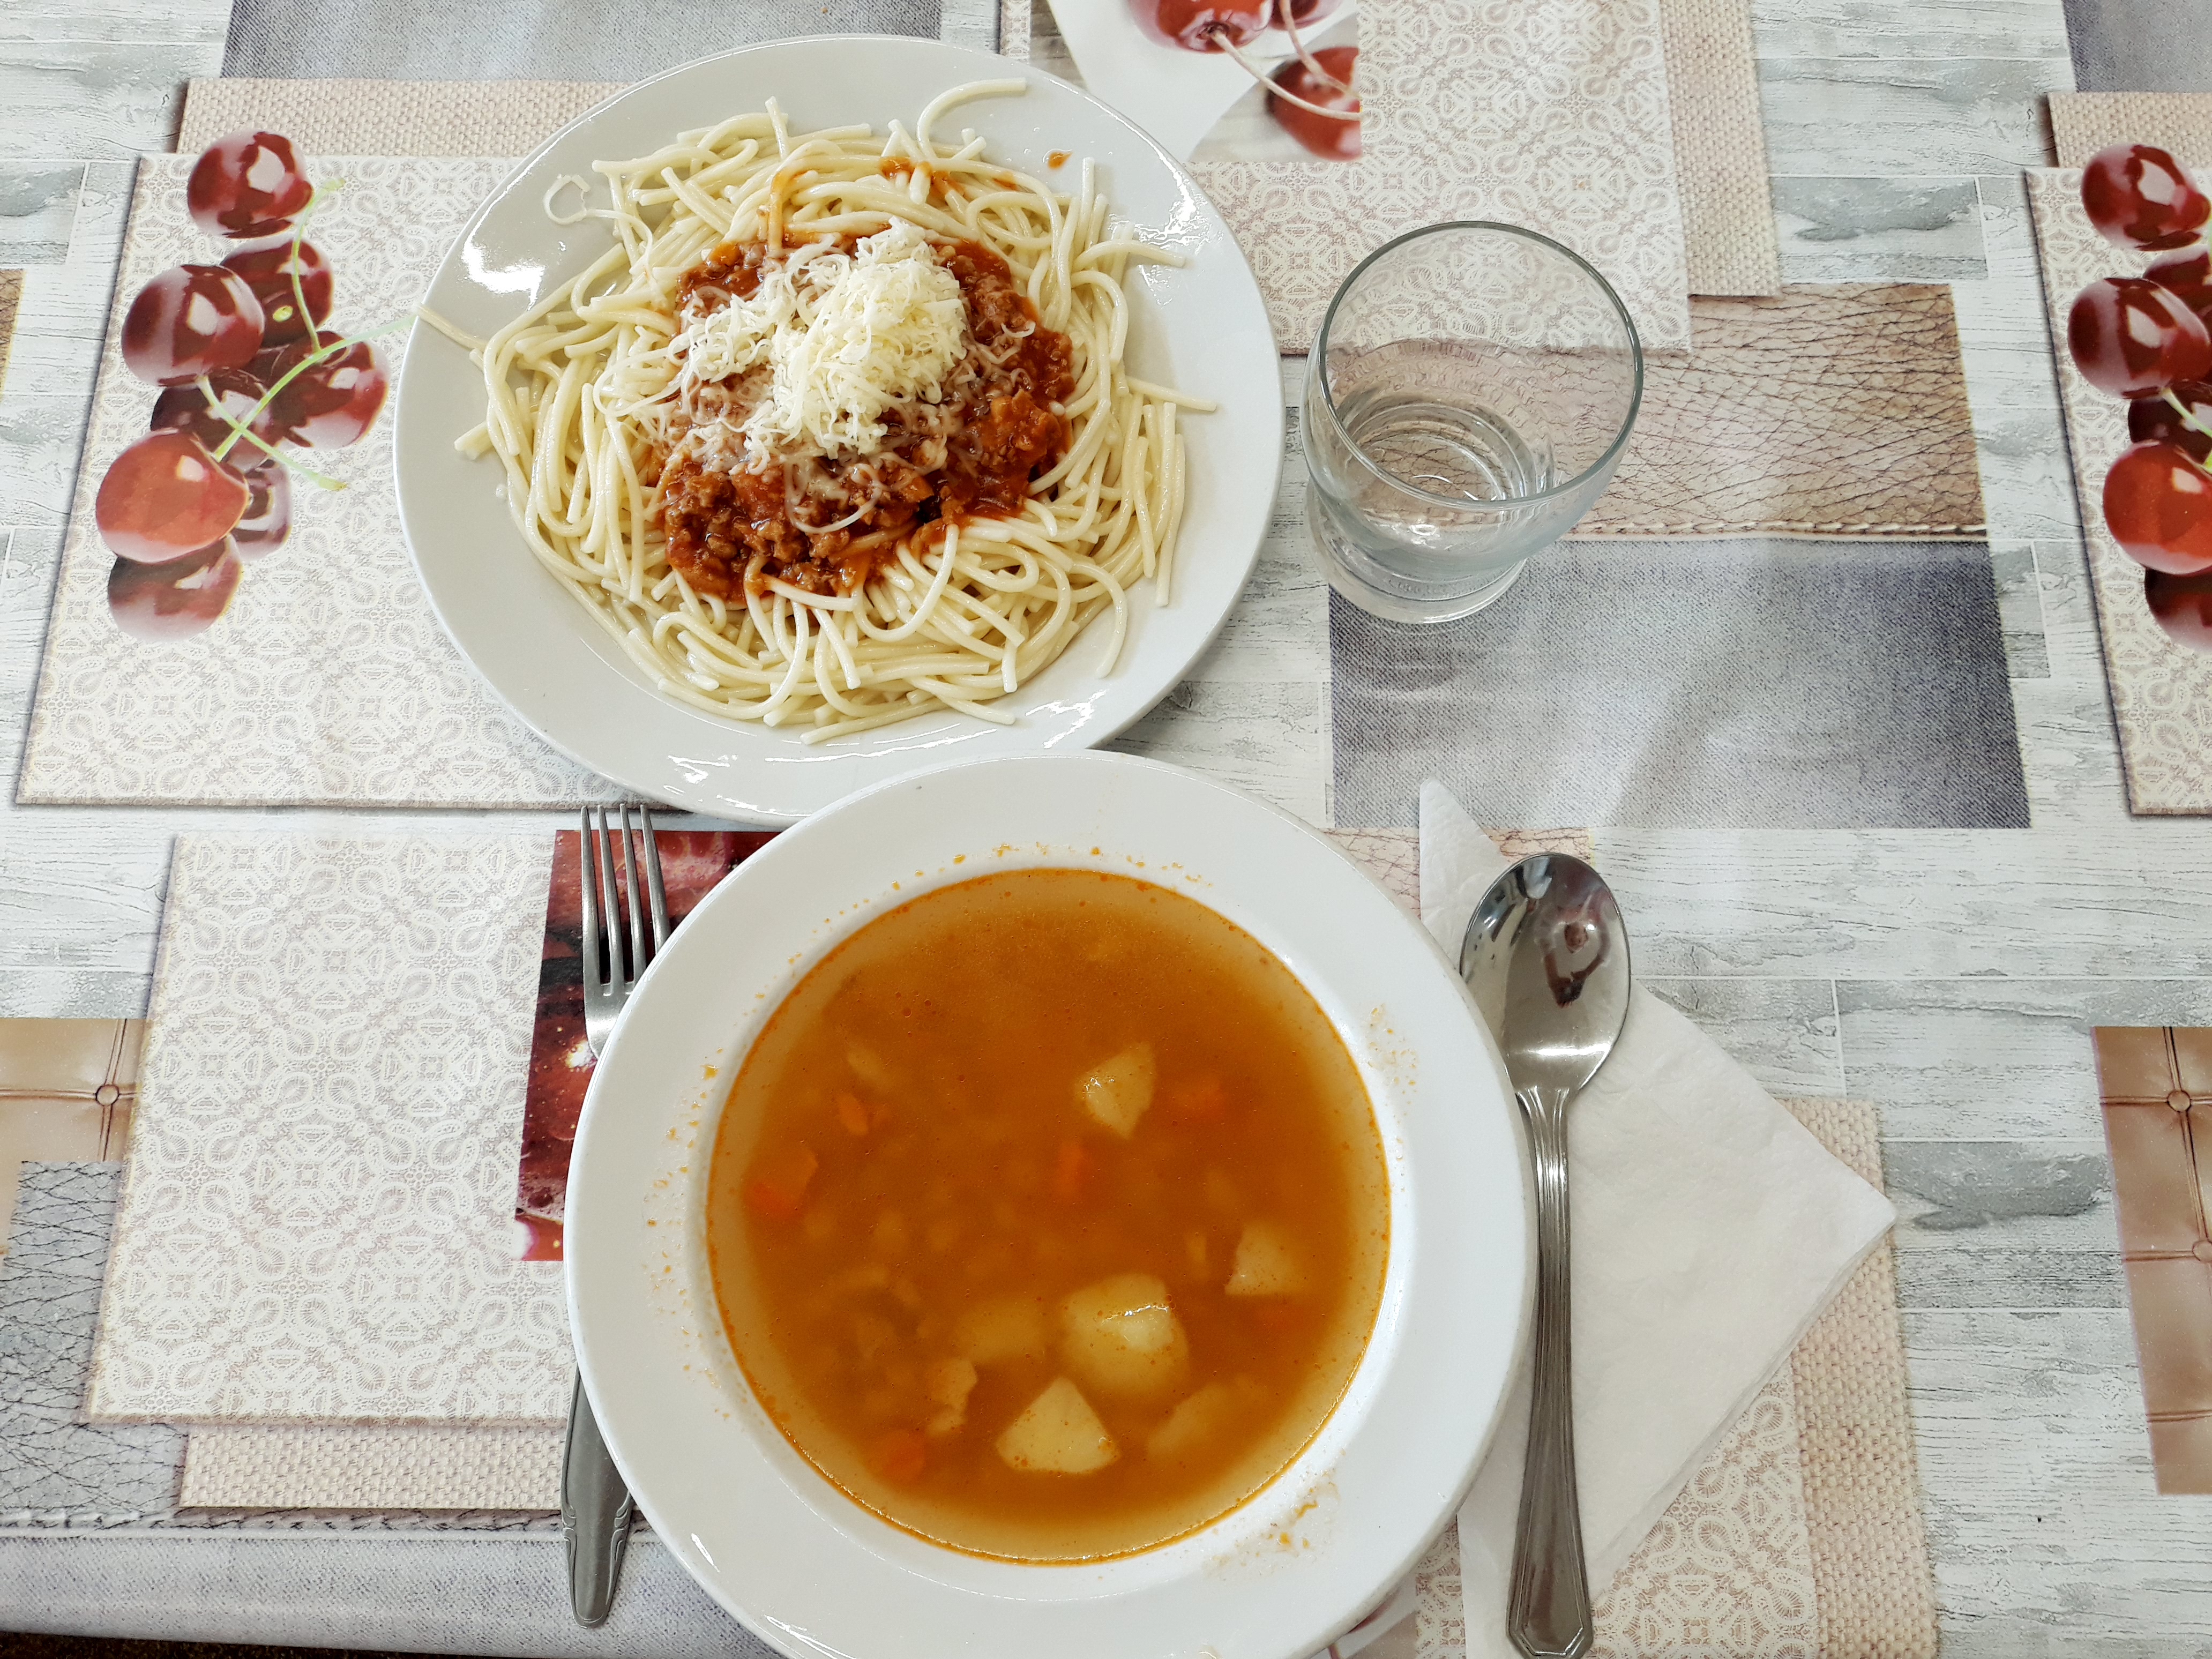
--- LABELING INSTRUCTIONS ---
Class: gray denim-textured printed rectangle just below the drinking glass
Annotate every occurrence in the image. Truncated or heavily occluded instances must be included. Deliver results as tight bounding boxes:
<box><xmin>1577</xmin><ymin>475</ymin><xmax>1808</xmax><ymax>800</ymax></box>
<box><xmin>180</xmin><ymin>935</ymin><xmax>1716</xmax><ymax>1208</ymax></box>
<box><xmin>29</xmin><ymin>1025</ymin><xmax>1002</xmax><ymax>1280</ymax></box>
<box><xmin>1329</xmin><ymin>540</ymin><xmax>2028</xmax><ymax>829</ymax></box>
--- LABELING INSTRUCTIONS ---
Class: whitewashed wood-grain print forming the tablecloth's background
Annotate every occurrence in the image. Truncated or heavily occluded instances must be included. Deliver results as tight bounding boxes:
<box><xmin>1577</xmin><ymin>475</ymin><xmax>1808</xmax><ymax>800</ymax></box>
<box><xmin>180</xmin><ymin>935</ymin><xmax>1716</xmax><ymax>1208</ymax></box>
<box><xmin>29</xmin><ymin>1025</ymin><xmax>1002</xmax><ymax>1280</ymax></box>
<box><xmin>0</xmin><ymin>0</ymin><xmax>2212</xmax><ymax>1659</ymax></box>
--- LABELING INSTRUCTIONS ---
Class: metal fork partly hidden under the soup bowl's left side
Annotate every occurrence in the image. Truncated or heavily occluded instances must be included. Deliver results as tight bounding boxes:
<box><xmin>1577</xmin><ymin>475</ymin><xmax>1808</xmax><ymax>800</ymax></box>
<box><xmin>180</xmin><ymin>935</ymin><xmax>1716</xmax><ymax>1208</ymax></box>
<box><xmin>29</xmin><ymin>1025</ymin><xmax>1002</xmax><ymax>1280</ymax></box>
<box><xmin>559</xmin><ymin>805</ymin><xmax>668</xmax><ymax>1628</ymax></box>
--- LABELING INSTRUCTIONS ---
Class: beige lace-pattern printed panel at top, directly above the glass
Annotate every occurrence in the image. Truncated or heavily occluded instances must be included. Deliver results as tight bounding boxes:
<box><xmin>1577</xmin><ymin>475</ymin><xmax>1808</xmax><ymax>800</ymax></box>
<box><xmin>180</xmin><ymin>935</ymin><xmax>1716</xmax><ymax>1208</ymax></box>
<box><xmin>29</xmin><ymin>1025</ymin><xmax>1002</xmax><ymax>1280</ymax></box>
<box><xmin>1002</xmin><ymin>0</ymin><xmax>1690</xmax><ymax>352</ymax></box>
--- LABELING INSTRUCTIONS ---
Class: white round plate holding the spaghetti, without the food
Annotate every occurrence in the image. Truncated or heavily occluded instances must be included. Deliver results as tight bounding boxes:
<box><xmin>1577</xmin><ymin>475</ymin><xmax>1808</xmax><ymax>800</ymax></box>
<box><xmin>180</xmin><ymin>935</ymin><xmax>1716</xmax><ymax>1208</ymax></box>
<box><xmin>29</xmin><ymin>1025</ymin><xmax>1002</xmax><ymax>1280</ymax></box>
<box><xmin>394</xmin><ymin>35</ymin><xmax>1283</xmax><ymax>825</ymax></box>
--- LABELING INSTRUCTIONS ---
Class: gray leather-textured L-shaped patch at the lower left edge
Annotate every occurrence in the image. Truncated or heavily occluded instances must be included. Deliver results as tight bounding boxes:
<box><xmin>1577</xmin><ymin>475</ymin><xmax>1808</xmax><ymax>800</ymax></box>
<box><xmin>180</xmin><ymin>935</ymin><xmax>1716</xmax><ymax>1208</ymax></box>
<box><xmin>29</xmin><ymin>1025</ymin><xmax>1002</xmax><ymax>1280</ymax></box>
<box><xmin>0</xmin><ymin>1163</ymin><xmax>184</xmax><ymax>1526</ymax></box>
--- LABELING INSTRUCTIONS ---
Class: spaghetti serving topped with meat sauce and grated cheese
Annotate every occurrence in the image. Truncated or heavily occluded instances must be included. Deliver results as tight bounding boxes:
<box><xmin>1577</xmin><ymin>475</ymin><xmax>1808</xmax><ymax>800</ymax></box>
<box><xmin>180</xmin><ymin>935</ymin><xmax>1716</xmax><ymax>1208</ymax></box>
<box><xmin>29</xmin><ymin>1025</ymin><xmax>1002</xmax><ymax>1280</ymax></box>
<box><xmin>462</xmin><ymin>82</ymin><xmax>1212</xmax><ymax>741</ymax></box>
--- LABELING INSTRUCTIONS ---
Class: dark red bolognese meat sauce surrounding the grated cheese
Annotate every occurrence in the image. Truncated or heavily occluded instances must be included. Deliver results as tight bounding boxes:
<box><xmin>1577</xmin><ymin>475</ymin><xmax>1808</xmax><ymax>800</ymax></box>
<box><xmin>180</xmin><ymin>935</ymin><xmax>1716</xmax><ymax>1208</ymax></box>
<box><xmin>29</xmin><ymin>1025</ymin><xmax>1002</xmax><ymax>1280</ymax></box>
<box><xmin>659</xmin><ymin>237</ymin><xmax>1075</xmax><ymax>600</ymax></box>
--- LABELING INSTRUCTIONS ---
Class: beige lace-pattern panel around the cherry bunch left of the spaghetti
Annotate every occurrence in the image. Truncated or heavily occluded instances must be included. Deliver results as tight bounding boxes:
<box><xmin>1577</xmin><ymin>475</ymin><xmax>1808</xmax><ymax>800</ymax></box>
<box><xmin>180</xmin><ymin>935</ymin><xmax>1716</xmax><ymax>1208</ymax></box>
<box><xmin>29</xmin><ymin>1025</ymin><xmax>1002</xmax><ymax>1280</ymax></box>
<box><xmin>18</xmin><ymin>155</ymin><xmax>612</xmax><ymax>808</ymax></box>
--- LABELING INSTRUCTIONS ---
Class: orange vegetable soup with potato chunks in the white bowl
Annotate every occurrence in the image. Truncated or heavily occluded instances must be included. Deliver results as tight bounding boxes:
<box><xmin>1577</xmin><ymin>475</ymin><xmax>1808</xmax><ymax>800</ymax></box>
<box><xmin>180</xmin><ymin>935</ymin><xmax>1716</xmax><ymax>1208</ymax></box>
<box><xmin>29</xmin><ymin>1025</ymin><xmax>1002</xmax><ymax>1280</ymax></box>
<box><xmin>706</xmin><ymin>869</ymin><xmax>1389</xmax><ymax>1559</ymax></box>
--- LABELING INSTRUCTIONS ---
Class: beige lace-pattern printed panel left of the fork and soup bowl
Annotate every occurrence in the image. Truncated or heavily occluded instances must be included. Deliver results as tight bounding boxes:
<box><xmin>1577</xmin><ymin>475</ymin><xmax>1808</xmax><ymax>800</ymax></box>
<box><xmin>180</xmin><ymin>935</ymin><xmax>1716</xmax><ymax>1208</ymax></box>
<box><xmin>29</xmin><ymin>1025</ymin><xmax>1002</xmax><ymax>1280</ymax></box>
<box><xmin>86</xmin><ymin>834</ymin><xmax>569</xmax><ymax>1427</ymax></box>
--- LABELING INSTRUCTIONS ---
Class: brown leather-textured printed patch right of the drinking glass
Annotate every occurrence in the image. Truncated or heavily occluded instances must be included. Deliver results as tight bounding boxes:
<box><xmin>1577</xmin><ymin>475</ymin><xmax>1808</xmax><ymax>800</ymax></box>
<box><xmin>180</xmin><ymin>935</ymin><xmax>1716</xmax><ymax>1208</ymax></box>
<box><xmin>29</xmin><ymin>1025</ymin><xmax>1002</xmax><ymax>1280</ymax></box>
<box><xmin>1573</xmin><ymin>283</ymin><xmax>1989</xmax><ymax>542</ymax></box>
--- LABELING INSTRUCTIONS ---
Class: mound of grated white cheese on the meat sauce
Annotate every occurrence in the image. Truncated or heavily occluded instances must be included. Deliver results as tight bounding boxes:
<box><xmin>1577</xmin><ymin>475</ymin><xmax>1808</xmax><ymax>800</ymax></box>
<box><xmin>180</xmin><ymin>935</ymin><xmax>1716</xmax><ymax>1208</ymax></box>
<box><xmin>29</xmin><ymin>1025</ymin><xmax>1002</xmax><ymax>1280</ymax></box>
<box><xmin>677</xmin><ymin>221</ymin><xmax>969</xmax><ymax>455</ymax></box>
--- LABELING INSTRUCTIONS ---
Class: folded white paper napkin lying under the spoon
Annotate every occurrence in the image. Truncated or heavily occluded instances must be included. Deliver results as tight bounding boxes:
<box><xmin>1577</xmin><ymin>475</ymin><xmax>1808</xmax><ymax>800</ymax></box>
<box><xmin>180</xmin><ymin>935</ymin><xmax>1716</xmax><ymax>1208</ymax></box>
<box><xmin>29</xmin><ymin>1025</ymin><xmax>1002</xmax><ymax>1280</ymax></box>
<box><xmin>1420</xmin><ymin>783</ymin><xmax>1896</xmax><ymax>1659</ymax></box>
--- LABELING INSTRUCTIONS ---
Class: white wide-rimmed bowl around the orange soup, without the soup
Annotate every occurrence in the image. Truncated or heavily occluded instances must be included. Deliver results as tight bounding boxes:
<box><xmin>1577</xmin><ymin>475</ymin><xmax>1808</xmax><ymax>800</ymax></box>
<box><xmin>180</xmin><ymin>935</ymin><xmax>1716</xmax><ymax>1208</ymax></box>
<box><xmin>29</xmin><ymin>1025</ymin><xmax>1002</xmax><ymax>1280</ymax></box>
<box><xmin>566</xmin><ymin>754</ymin><xmax>1531</xmax><ymax>1659</ymax></box>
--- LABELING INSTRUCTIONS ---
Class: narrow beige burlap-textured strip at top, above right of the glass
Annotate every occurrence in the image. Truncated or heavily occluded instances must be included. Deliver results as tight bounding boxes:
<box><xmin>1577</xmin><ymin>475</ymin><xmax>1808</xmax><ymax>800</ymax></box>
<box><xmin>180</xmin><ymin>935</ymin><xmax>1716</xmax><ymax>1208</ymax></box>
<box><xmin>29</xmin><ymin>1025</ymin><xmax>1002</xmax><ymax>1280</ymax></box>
<box><xmin>1659</xmin><ymin>0</ymin><xmax>1783</xmax><ymax>298</ymax></box>
